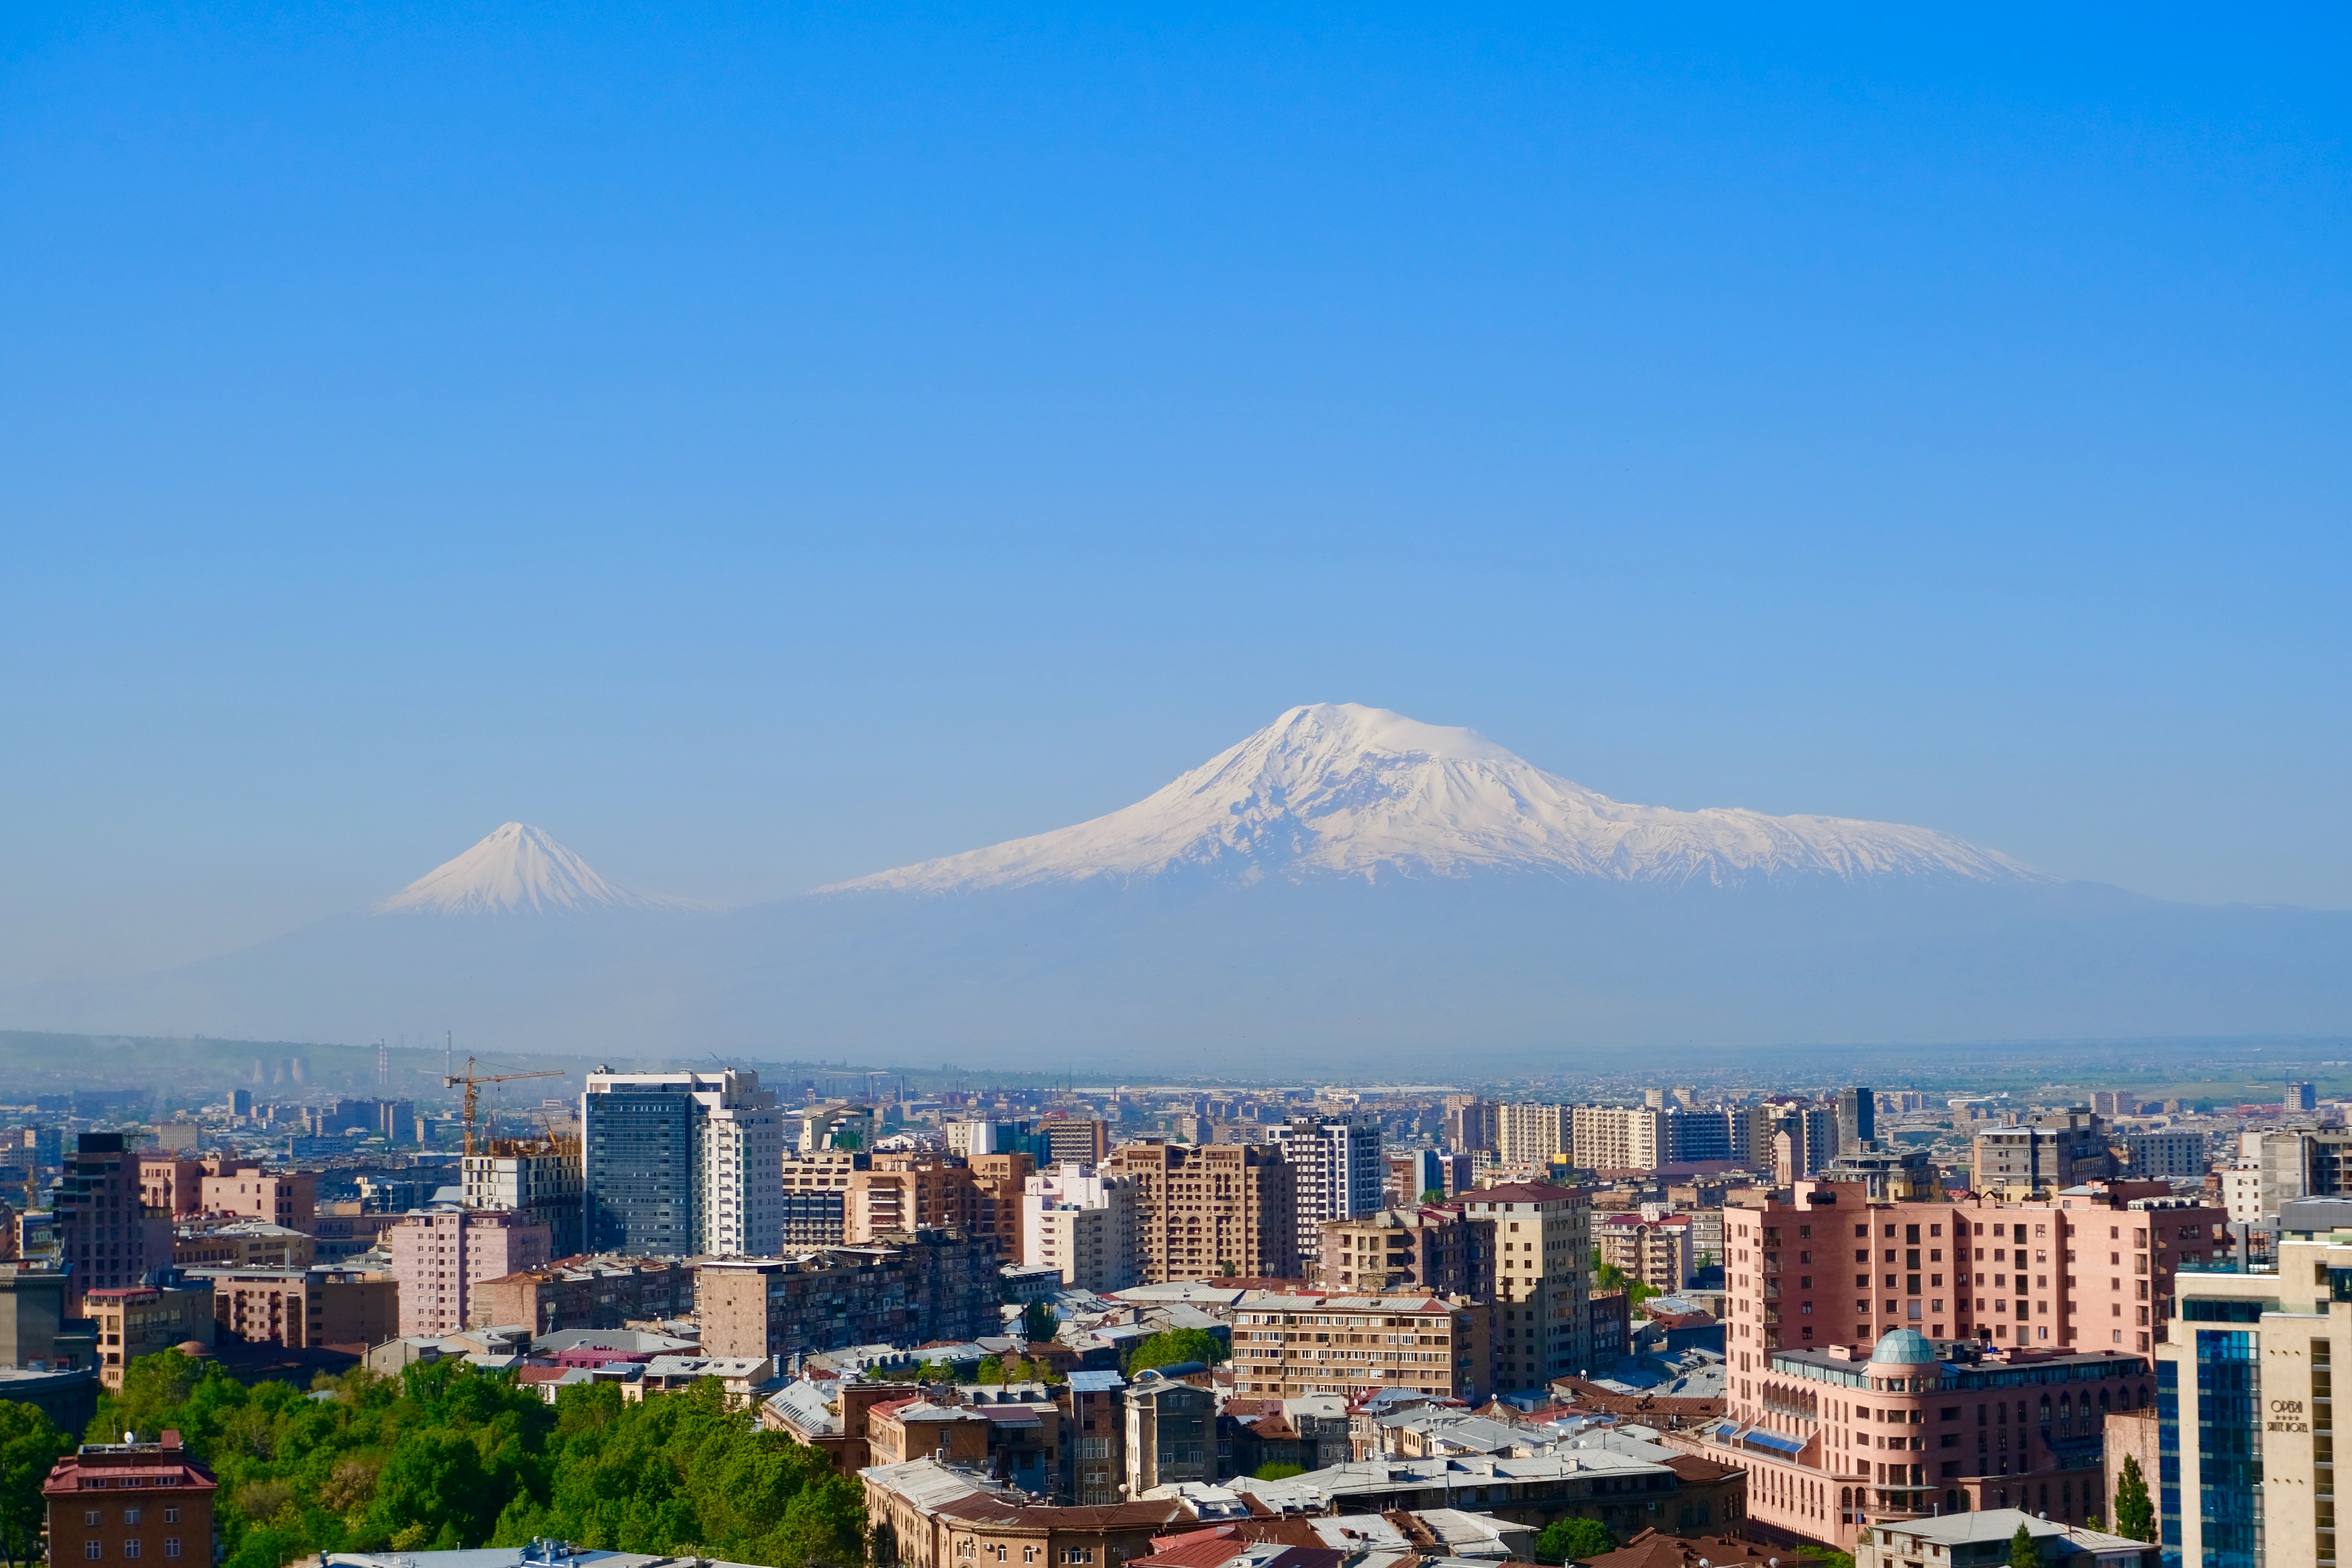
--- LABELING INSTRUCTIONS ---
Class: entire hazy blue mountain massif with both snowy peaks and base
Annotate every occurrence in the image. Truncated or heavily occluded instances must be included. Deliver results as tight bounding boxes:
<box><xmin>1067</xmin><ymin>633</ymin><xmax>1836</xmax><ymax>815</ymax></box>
<box><xmin>0</xmin><ymin>705</ymin><xmax>2352</xmax><ymax>1076</ymax></box>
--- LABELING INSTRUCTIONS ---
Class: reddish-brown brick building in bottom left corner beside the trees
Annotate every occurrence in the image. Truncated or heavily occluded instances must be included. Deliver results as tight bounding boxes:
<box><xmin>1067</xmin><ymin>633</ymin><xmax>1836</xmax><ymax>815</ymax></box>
<box><xmin>40</xmin><ymin>1432</ymin><xmax>216</xmax><ymax>1568</ymax></box>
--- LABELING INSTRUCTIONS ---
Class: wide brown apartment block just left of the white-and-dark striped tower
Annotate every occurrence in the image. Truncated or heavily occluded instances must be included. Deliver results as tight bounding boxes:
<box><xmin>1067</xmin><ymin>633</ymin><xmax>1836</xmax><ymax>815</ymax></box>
<box><xmin>1105</xmin><ymin>1142</ymin><xmax>1301</xmax><ymax>1283</ymax></box>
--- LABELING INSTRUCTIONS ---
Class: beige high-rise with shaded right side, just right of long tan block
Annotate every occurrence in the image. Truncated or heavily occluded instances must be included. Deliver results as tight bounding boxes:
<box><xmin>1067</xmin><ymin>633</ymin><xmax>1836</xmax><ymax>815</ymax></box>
<box><xmin>1456</xmin><ymin>1182</ymin><xmax>1592</xmax><ymax>1389</ymax></box>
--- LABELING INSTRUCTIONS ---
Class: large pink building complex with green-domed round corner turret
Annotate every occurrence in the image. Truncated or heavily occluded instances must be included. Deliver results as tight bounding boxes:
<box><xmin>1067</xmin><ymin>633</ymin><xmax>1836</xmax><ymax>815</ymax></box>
<box><xmin>1670</xmin><ymin>1180</ymin><xmax>2227</xmax><ymax>1549</ymax></box>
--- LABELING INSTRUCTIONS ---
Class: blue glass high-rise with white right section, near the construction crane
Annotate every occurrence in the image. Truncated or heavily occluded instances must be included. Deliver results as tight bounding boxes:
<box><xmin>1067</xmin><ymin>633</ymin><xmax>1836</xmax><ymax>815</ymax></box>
<box><xmin>581</xmin><ymin>1067</ymin><xmax>783</xmax><ymax>1258</ymax></box>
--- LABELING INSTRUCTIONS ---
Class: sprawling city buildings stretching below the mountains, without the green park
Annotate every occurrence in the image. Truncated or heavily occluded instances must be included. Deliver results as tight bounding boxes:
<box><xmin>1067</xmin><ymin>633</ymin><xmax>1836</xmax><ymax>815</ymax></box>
<box><xmin>0</xmin><ymin>1067</ymin><xmax>2352</xmax><ymax>1561</ymax></box>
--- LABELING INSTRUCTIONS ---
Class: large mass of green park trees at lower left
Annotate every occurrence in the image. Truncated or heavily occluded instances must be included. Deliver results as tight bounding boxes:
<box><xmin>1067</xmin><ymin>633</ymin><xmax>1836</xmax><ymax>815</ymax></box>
<box><xmin>87</xmin><ymin>1349</ymin><xmax>865</xmax><ymax>1568</ymax></box>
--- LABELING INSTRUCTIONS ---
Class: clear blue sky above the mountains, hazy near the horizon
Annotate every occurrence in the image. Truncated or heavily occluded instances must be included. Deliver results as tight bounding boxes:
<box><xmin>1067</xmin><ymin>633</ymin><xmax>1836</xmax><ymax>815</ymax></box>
<box><xmin>0</xmin><ymin>5</ymin><xmax>2352</xmax><ymax>983</ymax></box>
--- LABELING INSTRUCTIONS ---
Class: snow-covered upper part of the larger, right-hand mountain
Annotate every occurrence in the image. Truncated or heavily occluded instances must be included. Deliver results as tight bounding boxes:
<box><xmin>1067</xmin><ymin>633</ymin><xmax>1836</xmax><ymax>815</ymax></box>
<box><xmin>821</xmin><ymin>703</ymin><xmax>2046</xmax><ymax>893</ymax></box>
